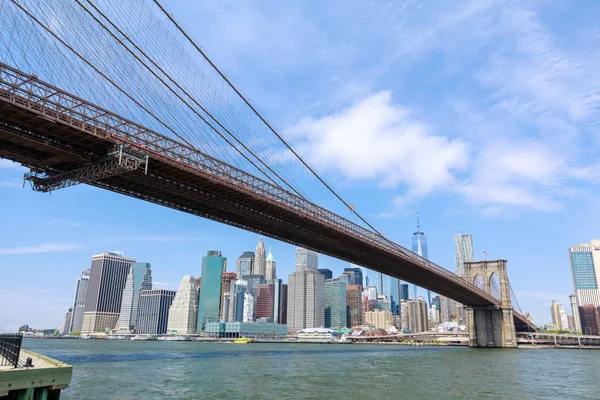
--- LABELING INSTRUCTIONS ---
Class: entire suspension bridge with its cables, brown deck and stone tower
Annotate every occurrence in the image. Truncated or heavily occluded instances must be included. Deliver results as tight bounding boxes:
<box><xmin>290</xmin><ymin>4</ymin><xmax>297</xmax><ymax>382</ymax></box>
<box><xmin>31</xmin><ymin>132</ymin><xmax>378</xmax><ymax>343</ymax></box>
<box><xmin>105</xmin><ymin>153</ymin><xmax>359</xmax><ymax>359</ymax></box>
<box><xmin>0</xmin><ymin>0</ymin><xmax>533</xmax><ymax>347</ymax></box>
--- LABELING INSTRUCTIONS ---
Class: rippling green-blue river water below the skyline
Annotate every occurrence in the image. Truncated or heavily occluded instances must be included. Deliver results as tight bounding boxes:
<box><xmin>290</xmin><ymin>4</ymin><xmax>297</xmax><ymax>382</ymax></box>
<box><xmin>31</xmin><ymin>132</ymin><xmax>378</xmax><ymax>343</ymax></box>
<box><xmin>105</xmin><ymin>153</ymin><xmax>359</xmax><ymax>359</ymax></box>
<box><xmin>24</xmin><ymin>339</ymin><xmax>600</xmax><ymax>400</ymax></box>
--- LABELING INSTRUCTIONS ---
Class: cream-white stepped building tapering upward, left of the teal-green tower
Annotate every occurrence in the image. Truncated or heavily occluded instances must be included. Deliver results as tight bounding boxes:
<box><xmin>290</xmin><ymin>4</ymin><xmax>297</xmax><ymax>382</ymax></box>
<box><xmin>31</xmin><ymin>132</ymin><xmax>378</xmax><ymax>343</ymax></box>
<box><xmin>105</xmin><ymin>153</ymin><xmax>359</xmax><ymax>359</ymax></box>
<box><xmin>167</xmin><ymin>276</ymin><xmax>198</xmax><ymax>335</ymax></box>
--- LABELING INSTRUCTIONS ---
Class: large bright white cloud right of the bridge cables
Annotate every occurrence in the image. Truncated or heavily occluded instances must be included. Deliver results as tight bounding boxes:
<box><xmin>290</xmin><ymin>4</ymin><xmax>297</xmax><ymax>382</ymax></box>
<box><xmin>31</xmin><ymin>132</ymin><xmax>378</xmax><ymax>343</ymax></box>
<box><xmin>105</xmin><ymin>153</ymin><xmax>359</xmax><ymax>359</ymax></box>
<box><xmin>287</xmin><ymin>91</ymin><xmax>468</xmax><ymax>196</ymax></box>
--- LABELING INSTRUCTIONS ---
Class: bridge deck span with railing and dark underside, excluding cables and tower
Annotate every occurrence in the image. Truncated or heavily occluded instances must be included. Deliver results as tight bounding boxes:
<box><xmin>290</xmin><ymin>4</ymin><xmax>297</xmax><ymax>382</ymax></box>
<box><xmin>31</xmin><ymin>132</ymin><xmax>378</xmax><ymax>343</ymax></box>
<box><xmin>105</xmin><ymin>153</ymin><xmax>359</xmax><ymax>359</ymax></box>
<box><xmin>0</xmin><ymin>63</ymin><xmax>533</xmax><ymax>331</ymax></box>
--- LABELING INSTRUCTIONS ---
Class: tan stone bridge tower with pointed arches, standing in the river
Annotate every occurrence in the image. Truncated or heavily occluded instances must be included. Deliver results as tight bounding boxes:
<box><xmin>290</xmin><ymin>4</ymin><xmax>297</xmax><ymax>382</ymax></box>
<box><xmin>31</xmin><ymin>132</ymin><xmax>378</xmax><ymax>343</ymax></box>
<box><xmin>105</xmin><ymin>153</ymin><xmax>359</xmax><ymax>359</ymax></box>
<box><xmin>463</xmin><ymin>260</ymin><xmax>517</xmax><ymax>347</ymax></box>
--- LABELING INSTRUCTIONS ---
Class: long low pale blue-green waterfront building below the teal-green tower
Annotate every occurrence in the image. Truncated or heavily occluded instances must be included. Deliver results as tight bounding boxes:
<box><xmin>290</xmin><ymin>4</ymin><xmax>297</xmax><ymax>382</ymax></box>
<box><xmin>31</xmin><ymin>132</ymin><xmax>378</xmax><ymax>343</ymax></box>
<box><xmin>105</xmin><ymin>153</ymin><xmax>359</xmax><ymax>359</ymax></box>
<box><xmin>204</xmin><ymin>322</ymin><xmax>288</xmax><ymax>340</ymax></box>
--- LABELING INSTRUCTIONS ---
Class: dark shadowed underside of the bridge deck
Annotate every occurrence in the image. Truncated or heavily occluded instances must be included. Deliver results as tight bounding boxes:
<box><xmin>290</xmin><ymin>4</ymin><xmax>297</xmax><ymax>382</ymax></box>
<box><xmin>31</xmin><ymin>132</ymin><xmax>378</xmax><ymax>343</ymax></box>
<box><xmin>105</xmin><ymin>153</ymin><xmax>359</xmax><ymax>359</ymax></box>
<box><xmin>0</xmin><ymin>92</ymin><xmax>526</xmax><ymax>330</ymax></box>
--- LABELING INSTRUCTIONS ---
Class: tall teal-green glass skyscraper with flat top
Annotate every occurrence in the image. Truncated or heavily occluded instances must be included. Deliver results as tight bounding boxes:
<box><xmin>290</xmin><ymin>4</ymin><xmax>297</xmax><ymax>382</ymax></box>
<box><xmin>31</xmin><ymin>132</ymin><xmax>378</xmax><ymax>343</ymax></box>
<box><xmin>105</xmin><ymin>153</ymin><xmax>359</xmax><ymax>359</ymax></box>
<box><xmin>197</xmin><ymin>250</ymin><xmax>227</xmax><ymax>333</ymax></box>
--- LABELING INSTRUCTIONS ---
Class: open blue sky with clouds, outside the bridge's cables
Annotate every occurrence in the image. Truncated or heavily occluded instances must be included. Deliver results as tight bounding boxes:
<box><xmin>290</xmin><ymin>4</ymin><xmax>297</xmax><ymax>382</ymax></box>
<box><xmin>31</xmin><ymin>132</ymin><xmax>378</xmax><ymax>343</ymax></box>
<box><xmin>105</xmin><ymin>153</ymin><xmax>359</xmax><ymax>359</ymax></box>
<box><xmin>0</xmin><ymin>0</ymin><xmax>600</xmax><ymax>331</ymax></box>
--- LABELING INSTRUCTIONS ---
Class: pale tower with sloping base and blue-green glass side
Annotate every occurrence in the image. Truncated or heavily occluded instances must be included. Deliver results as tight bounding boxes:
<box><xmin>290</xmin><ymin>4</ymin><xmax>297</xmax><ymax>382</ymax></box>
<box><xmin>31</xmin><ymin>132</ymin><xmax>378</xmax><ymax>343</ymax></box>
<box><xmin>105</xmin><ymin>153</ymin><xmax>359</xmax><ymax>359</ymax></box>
<box><xmin>116</xmin><ymin>262</ymin><xmax>152</xmax><ymax>332</ymax></box>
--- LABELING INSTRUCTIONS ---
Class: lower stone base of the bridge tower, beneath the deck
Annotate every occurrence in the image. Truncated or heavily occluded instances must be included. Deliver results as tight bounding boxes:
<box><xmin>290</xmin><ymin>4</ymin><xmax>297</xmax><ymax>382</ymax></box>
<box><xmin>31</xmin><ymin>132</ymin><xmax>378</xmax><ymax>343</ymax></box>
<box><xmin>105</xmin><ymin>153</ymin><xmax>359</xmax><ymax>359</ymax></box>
<box><xmin>466</xmin><ymin>306</ymin><xmax>517</xmax><ymax>347</ymax></box>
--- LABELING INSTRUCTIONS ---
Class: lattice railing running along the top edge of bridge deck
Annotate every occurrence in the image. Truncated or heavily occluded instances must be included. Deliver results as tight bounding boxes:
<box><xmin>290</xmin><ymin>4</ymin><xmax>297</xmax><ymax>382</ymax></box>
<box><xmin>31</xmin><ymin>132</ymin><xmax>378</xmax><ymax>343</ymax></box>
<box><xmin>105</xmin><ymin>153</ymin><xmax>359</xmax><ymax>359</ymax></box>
<box><xmin>0</xmin><ymin>62</ymin><xmax>499</xmax><ymax>304</ymax></box>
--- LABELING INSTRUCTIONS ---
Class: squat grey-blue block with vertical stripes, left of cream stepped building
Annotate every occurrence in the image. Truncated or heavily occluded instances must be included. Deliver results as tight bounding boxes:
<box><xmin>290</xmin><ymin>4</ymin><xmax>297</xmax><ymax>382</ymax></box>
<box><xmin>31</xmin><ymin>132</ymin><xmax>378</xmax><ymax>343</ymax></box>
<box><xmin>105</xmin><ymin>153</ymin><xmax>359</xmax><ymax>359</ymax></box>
<box><xmin>136</xmin><ymin>289</ymin><xmax>176</xmax><ymax>335</ymax></box>
